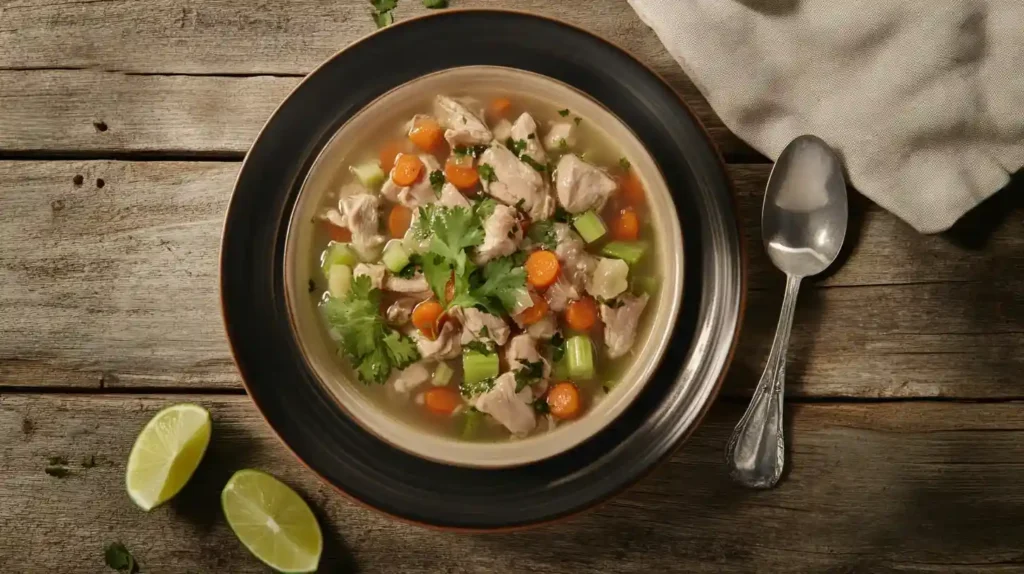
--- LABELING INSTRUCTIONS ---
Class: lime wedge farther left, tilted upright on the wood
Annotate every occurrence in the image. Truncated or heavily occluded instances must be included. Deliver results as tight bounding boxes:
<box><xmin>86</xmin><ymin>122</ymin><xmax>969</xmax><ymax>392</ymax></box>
<box><xmin>125</xmin><ymin>404</ymin><xmax>210</xmax><ymax>511</ymax></box>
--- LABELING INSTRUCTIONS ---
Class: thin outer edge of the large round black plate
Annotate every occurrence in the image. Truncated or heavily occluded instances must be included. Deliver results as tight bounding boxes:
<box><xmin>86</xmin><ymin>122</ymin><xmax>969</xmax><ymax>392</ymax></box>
<box><xmin>218</xmin><ymin>8</ymin><xmax>749</xmax><ymax>533</ymax></box>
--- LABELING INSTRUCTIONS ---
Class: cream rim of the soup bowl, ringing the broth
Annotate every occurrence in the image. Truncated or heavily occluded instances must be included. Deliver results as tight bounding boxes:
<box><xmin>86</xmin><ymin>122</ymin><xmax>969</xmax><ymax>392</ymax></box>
<box><xmin>283</xmin><ymin>64</ymin><xmax>686</xmax><ymax>469</ymax></box>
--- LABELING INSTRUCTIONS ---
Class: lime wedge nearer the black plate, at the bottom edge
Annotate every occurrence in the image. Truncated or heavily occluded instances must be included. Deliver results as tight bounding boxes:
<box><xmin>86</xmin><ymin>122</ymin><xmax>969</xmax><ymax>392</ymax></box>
<box><xmin>220</xmin><ymin>469</ymin><xmax>324</xmax><ymax>572</ymax></box>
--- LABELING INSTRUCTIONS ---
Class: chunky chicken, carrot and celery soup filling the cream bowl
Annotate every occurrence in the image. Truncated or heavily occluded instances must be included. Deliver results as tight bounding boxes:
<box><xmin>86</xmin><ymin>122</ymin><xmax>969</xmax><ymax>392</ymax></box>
<box><xmin>315</xmin><ymin>95</ymin><xmax>657</xmax><ymax>440</ymax></box>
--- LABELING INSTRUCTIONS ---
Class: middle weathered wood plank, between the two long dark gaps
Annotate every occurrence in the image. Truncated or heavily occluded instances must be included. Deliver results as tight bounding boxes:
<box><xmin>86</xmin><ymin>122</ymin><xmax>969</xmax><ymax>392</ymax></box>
<box><xmin>0</xmin><ymin>162</ymin><xmax>1024</xmax><ymax>397</ymax></box>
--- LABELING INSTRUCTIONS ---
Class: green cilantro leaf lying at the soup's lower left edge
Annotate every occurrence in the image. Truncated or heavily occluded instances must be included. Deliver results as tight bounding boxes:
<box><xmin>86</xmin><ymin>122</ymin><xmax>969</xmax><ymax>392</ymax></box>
<box><xmin>321</xmin><ymin>275</ymin><xmax>420</xmax><ymax>385</ymax></box>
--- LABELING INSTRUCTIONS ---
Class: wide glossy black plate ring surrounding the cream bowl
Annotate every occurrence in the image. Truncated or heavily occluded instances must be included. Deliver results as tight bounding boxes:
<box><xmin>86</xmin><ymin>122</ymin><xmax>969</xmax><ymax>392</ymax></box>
<box><xmin>221</xmin><ymin>10</ymin><xmax>743</xmax><ymax>530</ymax></box>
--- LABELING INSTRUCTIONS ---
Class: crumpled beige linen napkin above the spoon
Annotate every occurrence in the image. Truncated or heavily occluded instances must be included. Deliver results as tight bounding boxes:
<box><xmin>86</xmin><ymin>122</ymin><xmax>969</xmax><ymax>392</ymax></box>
<box><xmin>629</xmin><ymin>0</ymin><xmax>1024</xmax><ymax>233</ymax></box>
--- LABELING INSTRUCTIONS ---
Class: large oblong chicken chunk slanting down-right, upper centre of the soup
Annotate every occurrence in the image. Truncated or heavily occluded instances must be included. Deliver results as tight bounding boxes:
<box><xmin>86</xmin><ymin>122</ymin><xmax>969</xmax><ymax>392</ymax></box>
<box><xmin>479</xmin><ymin>143</ymin><xmax>555</xmax><ymax>220</ymax></box>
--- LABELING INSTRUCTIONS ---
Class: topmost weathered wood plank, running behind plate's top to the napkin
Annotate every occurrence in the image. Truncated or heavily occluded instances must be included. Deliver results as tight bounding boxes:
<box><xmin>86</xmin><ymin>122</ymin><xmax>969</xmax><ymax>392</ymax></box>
<box><xmin>0</xmin><ymin>0</ymin><xmax>760</xmax><ymax>159</ymax></box>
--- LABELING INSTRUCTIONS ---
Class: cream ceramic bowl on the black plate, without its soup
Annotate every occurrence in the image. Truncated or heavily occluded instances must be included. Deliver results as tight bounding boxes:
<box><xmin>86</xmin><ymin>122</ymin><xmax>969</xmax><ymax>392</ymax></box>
<box><xmin>285</xmin><ymin>67</ymin><xmax>683</xmax><ymax>468</ymax></box>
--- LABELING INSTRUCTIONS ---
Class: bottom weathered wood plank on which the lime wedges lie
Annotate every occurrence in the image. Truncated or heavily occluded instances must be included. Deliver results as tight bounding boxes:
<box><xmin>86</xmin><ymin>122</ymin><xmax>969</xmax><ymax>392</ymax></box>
<box><xmin>0</xmin><ymin>395</ymin><xmax>1024</xmax><ymax>574</ymax></box>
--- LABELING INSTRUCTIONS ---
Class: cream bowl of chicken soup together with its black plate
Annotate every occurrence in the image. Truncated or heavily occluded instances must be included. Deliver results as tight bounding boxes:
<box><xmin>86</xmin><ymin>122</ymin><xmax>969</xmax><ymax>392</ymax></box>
<box><xmin>221</xmin><ymin>11</ymin><xmax>742</xmax><ymax>528</ymax></box>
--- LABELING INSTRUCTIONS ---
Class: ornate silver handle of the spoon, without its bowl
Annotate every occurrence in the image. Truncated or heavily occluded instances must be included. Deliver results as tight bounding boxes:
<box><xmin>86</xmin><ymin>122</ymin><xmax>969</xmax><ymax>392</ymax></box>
<box><xmin>725</xmin><ymin>275</ymin><xmax>800</xmax><ymax>488</ymax></box>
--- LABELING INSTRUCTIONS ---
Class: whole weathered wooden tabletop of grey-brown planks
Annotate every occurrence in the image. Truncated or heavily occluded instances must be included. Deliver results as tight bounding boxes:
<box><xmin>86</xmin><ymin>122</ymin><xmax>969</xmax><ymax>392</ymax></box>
<box><xmin>0</xmin><ymin>0</ymin><xmax>1024</xmax><ymax>574</ymax></box>
